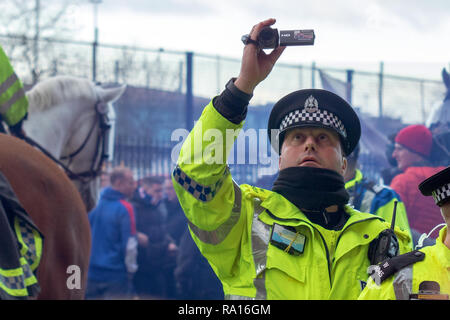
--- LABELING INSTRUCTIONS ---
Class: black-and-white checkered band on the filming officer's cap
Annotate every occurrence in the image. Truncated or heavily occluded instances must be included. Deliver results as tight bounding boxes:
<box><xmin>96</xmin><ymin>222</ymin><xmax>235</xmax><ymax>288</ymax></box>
<box><xmin>280</xmin><ymin>108</ymin><xmax>347</xmax><ymax>138</ymax></box>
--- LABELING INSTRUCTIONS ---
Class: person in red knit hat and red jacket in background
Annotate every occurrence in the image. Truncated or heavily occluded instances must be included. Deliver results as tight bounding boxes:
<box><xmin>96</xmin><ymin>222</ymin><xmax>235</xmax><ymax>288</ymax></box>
<box><xmin>390</xmin><ymin>125</ymin><xmax>444</xmax><ymax>240</ymax></box>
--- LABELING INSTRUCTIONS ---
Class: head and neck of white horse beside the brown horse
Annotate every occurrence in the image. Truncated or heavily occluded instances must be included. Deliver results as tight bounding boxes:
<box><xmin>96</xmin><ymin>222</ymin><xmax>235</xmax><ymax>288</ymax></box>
<box><xmin>23</xmin><ymin>76</ymin><xmax>126</xmax><ymax>211</ymax></box>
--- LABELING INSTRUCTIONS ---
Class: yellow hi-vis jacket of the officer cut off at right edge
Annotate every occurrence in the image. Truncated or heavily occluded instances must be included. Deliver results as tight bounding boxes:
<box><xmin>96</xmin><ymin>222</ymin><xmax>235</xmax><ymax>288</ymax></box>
<box><xmin>359</xmin><ymin>227</ymin><xmax>450</xmax><ymax>300</ymax></box>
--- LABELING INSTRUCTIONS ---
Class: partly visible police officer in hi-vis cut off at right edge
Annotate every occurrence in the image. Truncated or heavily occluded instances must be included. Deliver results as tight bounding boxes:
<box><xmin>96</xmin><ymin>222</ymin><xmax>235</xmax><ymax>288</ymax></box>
<box><xmin>360</xmin><ymin>167</ymin><xmax>450</xmax><ymax>300</ymax></box>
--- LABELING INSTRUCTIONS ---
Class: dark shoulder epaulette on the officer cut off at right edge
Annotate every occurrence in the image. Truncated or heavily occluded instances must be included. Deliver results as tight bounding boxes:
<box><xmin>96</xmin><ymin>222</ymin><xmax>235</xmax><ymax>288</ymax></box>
<box><xmin>367</xmin><ymin>250</ymin><xmax>425</xmax><ymax>285</ymax></box>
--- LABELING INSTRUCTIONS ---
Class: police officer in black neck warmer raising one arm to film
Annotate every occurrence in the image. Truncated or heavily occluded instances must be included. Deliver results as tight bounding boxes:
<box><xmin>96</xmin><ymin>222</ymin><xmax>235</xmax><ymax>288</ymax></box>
<box><xmin>172</xmin><ymin>19</ymin><xmax>409</xmax><ymax>299</ymax></box>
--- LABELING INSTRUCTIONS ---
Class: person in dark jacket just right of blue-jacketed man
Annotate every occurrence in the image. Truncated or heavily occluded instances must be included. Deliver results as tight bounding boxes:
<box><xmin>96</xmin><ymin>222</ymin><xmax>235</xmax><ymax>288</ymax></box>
<box><xmin>131</xmin><ymin>176</ymin><xmax>178</xmax><ymax>299</ymax></box>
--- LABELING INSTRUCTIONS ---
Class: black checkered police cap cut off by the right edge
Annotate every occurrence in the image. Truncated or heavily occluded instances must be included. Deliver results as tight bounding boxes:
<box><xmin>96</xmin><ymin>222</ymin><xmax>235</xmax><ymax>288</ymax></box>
<box><xmin>419</xmin><ymin>167</ymin><xmax>450</xmax><ymax>207</ymax></box>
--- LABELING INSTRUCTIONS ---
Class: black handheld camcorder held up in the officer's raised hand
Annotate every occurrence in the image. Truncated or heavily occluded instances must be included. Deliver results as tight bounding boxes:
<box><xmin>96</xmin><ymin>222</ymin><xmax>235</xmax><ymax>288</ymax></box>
<box><xmin>242</xmin><ymin>27</ymin><xmax>315</xmax><ymax>49</ymax></box>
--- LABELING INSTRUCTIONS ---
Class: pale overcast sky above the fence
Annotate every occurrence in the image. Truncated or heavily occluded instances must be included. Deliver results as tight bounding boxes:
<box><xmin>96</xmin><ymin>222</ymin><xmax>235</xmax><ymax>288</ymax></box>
<box><xmin>4</xmin><ymin>0</ymin><xmax>450</xmax><ymax>79</ymax></box>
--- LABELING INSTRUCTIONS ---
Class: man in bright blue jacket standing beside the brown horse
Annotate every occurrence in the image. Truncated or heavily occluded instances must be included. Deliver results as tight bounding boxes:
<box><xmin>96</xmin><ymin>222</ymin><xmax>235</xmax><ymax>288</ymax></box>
<box><xmin>86</xmin><ymin>167</ymin><xmax>137</xmax><ymax>299</ymax></box>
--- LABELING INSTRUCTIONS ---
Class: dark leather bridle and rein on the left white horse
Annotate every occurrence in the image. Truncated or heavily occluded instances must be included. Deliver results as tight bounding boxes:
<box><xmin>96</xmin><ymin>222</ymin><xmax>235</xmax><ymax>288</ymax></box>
<box><xmin>24</xmin><ymin>97</ymin><xmax>111</xmax><ymax>183</ymax></box>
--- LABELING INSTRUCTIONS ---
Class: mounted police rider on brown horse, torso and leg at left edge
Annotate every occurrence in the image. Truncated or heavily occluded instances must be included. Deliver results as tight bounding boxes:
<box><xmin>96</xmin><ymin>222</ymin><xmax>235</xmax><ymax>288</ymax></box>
<box><xmin>0</xmin><ymin>46</ymin><xmax>43</xmax><ymax>300</ymax></box>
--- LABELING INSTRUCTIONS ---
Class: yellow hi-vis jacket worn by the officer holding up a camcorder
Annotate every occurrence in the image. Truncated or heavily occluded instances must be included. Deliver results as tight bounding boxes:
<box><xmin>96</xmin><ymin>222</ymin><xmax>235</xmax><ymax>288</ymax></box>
<box><xmin>172</xmin><ymin>102</ymin><xmax>409</xmax><ymax>299</ymax></box>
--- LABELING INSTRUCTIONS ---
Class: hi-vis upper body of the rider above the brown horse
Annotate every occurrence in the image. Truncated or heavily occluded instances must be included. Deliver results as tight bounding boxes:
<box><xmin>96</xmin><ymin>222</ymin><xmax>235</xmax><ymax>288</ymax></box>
<box><xmin>0</xmin><ymin>46</ymin><xmax>28</xmax><ymax>137</ymax></box>
